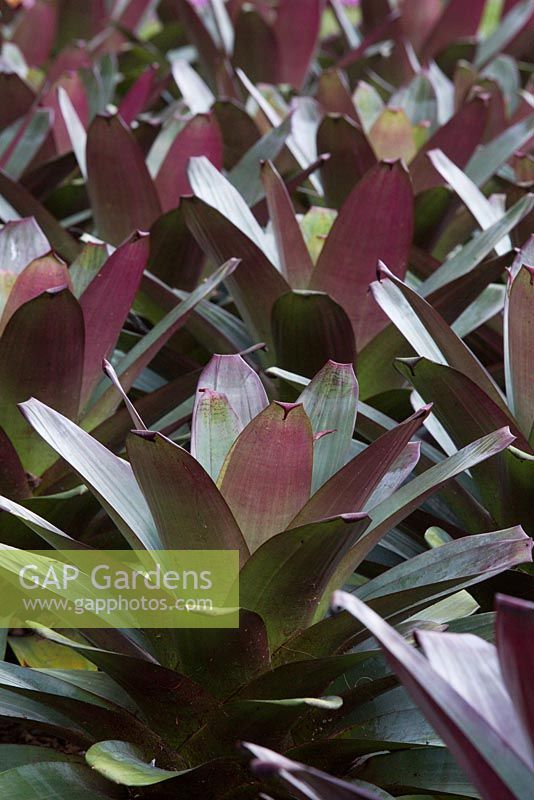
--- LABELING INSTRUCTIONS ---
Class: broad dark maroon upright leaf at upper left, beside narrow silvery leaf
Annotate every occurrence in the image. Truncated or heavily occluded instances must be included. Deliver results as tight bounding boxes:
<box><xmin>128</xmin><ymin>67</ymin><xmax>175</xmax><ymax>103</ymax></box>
<box><xmin>87</xmin><ymin>115</ymin><xmax>161</xmax><ymax>245</ymax></box>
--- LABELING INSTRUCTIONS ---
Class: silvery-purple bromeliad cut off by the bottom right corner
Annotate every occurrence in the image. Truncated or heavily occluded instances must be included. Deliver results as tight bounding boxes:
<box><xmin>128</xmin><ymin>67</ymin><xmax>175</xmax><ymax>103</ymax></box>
<box><xmin>333</xmin><ymin>592</ymin><xmax>534</xmax><ymax>800</ymax></box>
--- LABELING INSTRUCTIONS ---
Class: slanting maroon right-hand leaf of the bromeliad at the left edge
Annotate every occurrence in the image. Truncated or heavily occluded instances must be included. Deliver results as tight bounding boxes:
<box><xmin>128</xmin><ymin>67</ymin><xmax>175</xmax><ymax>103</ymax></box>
<box><xmin>80</xmin><ymin>234</ymin><xmax>148</xmax><ymax>405</ymax></box>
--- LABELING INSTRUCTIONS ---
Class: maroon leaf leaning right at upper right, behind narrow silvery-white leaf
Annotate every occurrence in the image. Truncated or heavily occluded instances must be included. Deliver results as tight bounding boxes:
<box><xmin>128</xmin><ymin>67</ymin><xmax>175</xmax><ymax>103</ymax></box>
<box><xmin>410</xmin><ymin>96</ymin><xmax>488</xmax><ymax>194</ymax></box>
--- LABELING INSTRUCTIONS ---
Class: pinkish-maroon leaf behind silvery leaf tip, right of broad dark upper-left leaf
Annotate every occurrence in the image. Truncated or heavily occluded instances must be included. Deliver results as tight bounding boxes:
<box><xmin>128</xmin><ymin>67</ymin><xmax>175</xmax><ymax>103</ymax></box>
<box><xmin>155</xmin><ymin>114</ymin><xmax>223</xmax><ymax>211</ymax></box>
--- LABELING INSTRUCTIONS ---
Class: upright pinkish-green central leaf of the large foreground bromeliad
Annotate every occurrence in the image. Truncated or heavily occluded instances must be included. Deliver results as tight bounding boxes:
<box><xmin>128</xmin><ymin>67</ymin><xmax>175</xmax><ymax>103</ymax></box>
<box><xmin>218</xmin><ymin>402</ymin><xmax>313</xmax><ymax>552</ymax></box>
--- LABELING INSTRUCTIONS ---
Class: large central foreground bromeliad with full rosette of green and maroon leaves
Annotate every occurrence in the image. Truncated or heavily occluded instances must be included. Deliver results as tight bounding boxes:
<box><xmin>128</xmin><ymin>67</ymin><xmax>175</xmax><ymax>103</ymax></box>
<box><xmin>0</xmin><ymin>356</ymin><xmax>531</xmax><ymax>797</ymax></box>
